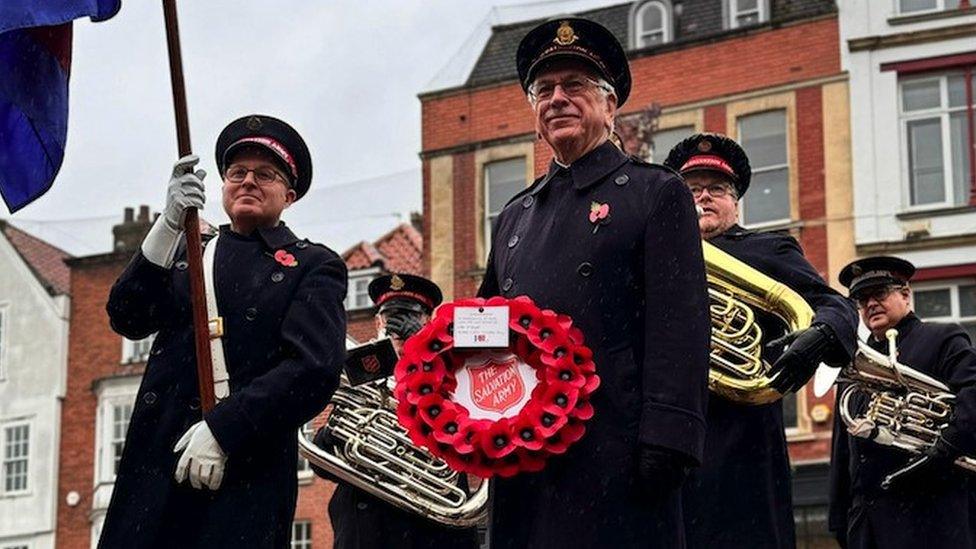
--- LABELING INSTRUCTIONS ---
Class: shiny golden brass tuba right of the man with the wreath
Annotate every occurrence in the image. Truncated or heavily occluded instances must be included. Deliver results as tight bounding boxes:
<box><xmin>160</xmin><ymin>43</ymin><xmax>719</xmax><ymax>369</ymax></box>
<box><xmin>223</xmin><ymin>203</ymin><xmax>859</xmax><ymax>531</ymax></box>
<box><xmin>702</xmin><ymin>242</ymin><xmax>813</xmax><ymax>404</ymax></box>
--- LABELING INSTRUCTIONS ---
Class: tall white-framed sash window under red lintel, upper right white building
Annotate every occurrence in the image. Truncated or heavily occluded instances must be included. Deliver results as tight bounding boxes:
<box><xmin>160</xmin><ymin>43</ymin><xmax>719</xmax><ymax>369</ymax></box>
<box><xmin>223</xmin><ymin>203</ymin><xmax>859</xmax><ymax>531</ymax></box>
<box><xmin>896</xmin><ymin>70</ymin><xmax>976</xmax><ymax>212</ymax></box>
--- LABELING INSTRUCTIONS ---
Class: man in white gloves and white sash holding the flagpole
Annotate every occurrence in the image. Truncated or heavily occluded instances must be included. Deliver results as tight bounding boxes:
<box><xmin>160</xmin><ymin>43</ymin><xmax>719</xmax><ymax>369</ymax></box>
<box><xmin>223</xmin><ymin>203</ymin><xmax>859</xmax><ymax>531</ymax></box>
<box><xmin>100</xmin><ymin>115</ymin><xmax>346</xmax><ymax>548</ymax></box>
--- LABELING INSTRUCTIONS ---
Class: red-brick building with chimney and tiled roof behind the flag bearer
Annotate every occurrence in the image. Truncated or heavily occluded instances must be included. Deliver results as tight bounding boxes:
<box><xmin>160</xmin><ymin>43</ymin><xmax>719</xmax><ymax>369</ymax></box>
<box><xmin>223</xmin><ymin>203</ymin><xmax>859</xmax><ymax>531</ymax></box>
<box><xmin>52</xmin><ymin>206</ymin><xmax>423</xmax><ymax>549</ymax></box>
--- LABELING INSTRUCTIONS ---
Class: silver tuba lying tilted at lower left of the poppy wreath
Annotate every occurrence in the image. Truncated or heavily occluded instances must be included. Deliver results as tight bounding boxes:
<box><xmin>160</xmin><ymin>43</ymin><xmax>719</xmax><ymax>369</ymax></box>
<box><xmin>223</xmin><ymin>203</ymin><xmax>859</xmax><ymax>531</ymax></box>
<box><xmin>298</xmin><ymin>374</ymin><xmax>489</xmax><ymax>527</ymax></box>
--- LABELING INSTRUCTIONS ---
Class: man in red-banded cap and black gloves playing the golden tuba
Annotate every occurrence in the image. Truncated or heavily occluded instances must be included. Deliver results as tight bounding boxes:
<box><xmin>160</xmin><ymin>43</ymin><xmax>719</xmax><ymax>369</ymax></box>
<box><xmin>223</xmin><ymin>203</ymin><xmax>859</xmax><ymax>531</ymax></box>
<box><xmin>665</xmin><ymin>133</ymin><xmax>857</xmax><ymax>548</ymax></box>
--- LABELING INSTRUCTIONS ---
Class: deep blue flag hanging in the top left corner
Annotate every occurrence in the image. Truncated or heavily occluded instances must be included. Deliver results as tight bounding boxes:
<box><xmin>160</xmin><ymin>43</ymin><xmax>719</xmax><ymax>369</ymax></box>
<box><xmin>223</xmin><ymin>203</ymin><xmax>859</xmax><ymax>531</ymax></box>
<box><xmin>0</xmin><ymin>0</ymin><xmax>121</xmax><ymax>212</ymax></box>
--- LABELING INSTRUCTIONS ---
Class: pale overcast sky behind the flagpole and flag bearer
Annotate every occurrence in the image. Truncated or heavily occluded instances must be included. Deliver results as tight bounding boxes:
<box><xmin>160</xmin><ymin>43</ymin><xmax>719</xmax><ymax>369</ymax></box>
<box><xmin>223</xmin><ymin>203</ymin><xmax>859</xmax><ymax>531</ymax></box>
<box><xmin>0</xmin><ymin>0</ymin><xmax>614</xmax><ymax>255</ymax></box>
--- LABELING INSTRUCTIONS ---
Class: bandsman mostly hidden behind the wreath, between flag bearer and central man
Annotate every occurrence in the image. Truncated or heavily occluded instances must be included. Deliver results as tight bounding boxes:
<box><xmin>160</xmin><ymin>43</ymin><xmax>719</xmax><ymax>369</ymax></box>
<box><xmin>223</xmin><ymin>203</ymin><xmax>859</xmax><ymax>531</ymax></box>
<box><xmin>313</xmin><ymin>273</ymin><xmax>478</xmax><ymax>549</ymax></box>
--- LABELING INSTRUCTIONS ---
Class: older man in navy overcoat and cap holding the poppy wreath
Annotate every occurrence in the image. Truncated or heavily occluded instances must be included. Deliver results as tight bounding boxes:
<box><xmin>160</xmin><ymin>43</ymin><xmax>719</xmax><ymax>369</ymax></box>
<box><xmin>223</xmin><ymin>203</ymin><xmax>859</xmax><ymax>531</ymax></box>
<box><xmin>479</xmin><ymin>18</ymin><xmax>709</xmax><ymax>548</ymax></box>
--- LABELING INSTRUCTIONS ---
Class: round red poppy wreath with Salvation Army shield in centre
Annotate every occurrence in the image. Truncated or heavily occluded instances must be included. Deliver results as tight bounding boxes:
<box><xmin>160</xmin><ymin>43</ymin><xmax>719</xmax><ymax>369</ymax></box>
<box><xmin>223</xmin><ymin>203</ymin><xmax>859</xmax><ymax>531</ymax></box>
<box><xmin>395</xmin><ymin>296</ymin><xmax>600</xmax><ymax>478</ymax></box>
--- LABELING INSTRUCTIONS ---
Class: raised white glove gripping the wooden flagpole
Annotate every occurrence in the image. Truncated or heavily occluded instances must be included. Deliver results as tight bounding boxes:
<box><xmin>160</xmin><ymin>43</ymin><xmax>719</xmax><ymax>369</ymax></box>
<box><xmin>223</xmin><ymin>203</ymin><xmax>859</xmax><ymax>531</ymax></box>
<box><xmin>142</xmin><ymin>154</ymin><xmax>207</xmax><ymax>269</ymax></box>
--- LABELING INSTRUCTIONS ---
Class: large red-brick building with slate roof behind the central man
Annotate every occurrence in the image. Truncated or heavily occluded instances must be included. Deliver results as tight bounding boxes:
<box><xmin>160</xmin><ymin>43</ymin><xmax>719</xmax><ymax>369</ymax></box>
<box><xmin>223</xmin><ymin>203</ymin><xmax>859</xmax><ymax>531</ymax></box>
<box><xmin>420</xmin><ymin>0</ymin><xmax>854</xmax><ymax>544</ymax></box>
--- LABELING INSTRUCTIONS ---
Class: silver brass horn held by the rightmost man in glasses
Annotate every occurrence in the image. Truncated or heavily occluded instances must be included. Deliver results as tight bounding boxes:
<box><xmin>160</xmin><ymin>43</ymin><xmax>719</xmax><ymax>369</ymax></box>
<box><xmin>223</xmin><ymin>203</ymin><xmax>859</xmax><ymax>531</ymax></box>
<box><xmin>832</xmin><ymin>329</ymin><xmax>976</xmax><ymax>488</ymax></box>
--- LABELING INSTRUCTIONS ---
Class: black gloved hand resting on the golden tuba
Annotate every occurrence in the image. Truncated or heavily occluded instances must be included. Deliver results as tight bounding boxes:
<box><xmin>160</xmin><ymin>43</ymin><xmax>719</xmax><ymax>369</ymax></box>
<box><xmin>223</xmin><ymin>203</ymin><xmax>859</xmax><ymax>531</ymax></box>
<box><xmin>766</xmin><ymin>324</ymin><xmax>839</xmax><ymax>395</ymax></box>
